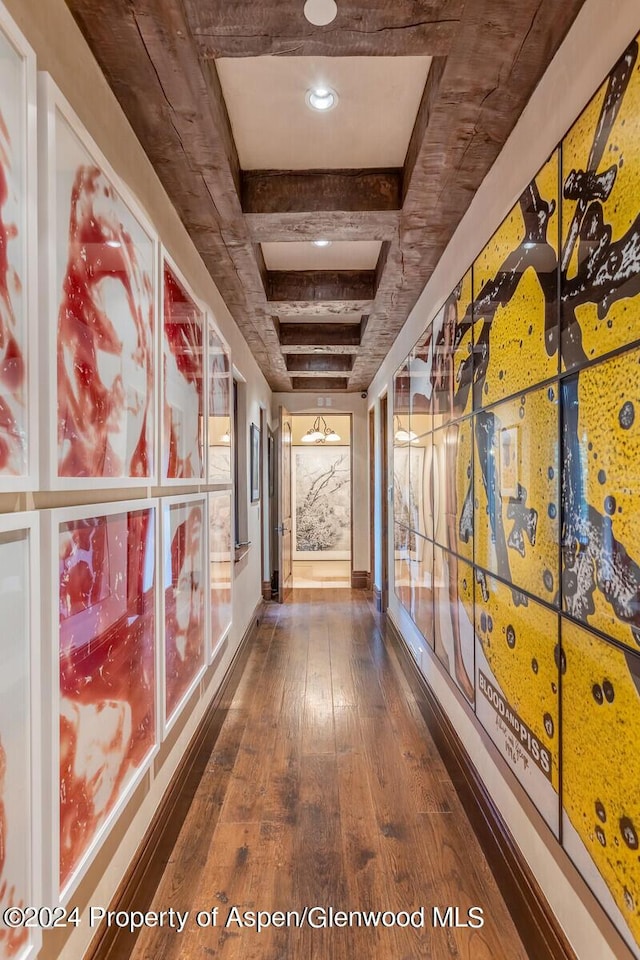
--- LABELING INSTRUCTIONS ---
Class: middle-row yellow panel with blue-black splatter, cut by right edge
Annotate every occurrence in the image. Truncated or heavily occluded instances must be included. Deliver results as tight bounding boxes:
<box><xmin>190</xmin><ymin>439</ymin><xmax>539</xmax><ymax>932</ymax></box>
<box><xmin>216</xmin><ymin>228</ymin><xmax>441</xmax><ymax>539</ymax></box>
<box><xmin>562</xmin><ymin>348</ymin><xmax>640</xmax><ymax>650</ymax></box>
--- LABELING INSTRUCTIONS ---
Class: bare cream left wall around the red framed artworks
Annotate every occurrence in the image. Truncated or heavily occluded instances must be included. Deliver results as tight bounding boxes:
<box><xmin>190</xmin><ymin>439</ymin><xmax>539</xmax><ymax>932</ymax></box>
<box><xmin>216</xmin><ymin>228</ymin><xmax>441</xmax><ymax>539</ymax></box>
<box><xmin>0</xmin><ymin>0</ymin><xmax>271</xmax><ymax>960</ymax></box>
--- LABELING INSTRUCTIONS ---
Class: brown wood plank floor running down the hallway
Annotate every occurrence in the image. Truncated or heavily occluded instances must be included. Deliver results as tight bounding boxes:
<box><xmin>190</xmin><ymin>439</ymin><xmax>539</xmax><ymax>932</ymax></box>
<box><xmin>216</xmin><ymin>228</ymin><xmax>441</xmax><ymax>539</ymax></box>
<box><xmin>125</xmin><ymin>590</ymin><xmax>527</xmax><ymax>960</ymax></box>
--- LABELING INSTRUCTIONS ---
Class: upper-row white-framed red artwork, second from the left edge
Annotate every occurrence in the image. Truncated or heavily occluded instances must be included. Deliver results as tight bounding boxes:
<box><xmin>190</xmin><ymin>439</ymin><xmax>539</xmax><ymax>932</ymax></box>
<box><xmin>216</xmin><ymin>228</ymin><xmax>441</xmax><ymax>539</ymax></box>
<box><xmin>39</xmin><ymin>75</ymin><xmax>157</xmax><ymax>489</ymax></box>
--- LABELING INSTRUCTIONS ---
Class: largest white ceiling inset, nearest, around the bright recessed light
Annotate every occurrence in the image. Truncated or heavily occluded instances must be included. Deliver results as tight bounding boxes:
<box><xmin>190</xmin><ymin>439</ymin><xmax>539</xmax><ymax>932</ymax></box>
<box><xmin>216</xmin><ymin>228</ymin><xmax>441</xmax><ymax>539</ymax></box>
<box><xmin>216</xmin><ymin>57</ymin><xmax>431</xmax><ymax>170</ymax></box>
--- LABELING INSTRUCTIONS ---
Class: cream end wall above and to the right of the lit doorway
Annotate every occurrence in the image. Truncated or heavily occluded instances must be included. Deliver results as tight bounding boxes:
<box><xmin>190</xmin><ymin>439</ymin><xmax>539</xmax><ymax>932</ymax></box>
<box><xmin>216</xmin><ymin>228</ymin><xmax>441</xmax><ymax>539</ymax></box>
<box><xmin>272</xmin><ymin>390</ymin><xmax>369</xmax><ymax>571</ymax></box>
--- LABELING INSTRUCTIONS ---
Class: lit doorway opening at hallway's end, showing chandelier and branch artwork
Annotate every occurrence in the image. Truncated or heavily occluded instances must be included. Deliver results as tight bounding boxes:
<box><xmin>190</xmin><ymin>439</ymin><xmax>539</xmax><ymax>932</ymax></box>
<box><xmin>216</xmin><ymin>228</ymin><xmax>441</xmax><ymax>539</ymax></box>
<box><xmin>292</xmin><ymin>413</ymin><xmax>352</xmax><ymax>589</ymax></box>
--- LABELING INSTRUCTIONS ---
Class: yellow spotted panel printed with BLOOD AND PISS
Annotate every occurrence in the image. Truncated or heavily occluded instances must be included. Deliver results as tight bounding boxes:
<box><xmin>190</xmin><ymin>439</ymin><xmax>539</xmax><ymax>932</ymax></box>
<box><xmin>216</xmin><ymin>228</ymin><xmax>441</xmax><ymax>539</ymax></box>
<box><xmin>475</xmin><ymin>570</ymin><xmax>560</xmax><ymax>837</ymax></box>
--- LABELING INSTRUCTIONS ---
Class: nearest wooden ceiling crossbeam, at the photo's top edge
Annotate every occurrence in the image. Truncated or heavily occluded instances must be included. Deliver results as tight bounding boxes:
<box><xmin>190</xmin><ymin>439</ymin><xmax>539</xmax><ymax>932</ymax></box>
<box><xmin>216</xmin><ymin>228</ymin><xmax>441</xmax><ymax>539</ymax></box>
<box><xmin>183</xmin><ymin>0</ymin><xmax>464</xmax><ymax>59</ymax></box>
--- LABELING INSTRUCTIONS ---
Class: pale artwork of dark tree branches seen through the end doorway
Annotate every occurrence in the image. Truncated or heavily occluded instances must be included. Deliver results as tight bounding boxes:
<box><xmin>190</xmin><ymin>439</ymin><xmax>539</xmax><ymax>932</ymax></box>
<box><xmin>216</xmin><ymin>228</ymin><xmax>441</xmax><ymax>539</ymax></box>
<box><xmin>295</xmin><ymin>445</ymin><xmax>351</xmax><ymax>560</ymax></box>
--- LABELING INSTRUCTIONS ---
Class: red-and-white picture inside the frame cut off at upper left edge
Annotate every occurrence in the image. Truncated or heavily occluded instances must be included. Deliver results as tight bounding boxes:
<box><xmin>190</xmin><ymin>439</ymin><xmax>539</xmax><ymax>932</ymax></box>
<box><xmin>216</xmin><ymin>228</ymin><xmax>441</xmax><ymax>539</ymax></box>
<box><xmin>0</xmin><ymin>16</ymin><xmax>36</xmax><ymax>481</ymax></box>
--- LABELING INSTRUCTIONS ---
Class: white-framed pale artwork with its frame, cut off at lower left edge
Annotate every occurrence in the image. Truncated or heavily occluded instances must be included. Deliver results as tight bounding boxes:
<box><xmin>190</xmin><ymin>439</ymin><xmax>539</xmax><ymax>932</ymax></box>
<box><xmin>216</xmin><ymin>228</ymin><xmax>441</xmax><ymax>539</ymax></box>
<box><xmin>0</xmin><ymin>513</ymin><xmax>43</xmax><ymax>960</ymax></box>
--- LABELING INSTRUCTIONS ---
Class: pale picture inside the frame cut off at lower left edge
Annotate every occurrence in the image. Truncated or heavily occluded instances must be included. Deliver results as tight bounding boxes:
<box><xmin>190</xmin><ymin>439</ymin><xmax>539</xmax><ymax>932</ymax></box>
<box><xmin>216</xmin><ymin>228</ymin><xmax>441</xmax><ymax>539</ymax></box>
<box><xmin>0</xmin><ymin>525</ymin><xmax>37</xmax><ymax>960</ymax></box>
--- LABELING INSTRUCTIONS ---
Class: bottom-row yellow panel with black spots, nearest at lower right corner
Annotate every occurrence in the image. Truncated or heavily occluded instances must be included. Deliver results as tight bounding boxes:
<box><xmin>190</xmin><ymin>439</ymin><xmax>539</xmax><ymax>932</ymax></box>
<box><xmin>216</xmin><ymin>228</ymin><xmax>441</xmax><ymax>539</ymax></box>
<box><xmin>562</xmin><ymin>620</ymin><xmax>640</xmax><ymax>957</ymax></box>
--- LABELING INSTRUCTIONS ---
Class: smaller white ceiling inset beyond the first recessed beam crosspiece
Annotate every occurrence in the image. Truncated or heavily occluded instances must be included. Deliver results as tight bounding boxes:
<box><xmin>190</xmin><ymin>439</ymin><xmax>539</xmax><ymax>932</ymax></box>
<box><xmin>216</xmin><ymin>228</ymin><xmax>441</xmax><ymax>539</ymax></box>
<box><xmin>261</xmin><ymin>240</ymin><xmax>382</xmax><ymax>270</ymax></box>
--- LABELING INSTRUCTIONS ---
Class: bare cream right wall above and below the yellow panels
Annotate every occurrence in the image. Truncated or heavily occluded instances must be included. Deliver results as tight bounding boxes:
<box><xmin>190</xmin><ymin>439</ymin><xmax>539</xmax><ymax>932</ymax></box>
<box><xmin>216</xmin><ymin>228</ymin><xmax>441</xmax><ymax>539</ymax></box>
<box><xmin>369</xmin><ymin>0</ymin><xmax>640</xmax><ymax>960</ymax></box>
